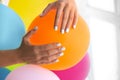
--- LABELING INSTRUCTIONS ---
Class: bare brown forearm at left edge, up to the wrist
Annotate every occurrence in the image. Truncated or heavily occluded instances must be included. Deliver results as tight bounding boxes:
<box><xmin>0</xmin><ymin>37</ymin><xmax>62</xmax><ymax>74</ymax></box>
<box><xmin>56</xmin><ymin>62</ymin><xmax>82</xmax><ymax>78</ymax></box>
<box><xmin>0</xmin><ymin>49</ymin><xmax>20</xmax><ymax>67</ymax></box>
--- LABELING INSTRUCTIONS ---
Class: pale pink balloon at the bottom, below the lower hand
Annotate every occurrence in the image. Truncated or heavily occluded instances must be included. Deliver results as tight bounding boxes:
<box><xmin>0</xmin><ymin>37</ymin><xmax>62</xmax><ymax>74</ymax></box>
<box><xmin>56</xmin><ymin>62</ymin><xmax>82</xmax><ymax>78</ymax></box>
<box><xmin>5</xmin><ymin>65</ymin><xmax>60</xmax><ymax>80</ymax></box>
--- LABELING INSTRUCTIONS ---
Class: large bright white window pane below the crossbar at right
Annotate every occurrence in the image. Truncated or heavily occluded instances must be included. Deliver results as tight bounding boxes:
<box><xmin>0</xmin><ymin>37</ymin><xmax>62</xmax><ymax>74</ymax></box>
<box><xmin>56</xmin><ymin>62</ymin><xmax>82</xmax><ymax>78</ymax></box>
<box><xmin>89</xmin><ymin>18</ymin><xmax>117</xmax><ymax>80</ymax></box>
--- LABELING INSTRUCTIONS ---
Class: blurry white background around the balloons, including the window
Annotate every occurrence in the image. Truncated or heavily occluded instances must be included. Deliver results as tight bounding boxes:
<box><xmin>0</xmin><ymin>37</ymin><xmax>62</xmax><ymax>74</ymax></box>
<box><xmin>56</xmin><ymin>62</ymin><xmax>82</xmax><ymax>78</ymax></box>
<box><xmin>3</xmin><ymin>0</ymin><xmax>120</xmax><ymax>80</ymax></box>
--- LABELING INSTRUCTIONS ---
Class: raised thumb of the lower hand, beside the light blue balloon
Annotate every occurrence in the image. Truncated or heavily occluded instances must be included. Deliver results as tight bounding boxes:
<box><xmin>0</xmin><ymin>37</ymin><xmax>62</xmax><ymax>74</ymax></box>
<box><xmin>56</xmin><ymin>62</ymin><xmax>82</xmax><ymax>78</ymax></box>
<box><xmin>23</xmin><ymin>26</ymin><xmax>38</xmax><ymax>44</ymax></box>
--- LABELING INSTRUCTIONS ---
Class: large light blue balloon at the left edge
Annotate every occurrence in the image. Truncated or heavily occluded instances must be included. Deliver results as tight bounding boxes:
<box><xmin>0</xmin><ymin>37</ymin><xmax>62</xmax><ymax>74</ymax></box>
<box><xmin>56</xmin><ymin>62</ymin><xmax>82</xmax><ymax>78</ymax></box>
<box><xmin>0</xmin><ymin>4</ymin><xmax>25</xmax><ymax>50</ymax></box>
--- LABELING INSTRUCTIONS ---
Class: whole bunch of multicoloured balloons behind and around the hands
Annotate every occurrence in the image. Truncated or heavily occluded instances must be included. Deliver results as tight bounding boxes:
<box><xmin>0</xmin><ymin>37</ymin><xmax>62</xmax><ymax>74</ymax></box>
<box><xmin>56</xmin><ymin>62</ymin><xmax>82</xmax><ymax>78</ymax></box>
<box><xmin>0</xmin><ymin>0</ymin><xmax>89</xmax><ymax>80</ymax></box>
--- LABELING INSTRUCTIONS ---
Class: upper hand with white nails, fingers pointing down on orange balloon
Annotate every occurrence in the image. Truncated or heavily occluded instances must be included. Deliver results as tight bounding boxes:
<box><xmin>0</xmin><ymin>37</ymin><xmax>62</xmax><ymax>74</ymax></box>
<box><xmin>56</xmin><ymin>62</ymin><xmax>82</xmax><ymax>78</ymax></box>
<box><xmin>41</xmin><ymin>0</ymin><xmax>78</xmax><ymax>34</ymax></box>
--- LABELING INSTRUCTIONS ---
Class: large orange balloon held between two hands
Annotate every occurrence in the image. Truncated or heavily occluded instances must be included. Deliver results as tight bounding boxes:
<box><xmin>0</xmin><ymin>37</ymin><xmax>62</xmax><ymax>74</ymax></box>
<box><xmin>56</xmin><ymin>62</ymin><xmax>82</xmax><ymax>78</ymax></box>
<box><xmin>28</xmin><ymin>9</ymin><xmax>90</xmax><ymax>70</ymax></box>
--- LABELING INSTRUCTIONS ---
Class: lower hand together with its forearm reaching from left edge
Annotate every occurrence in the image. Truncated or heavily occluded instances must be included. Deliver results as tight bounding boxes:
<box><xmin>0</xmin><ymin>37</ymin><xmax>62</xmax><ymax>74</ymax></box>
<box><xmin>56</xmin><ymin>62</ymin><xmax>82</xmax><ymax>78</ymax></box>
<box><xmin>0</xmin><ymin>27</ymin><xmax>65</xmax><ymax>67</ymax></box>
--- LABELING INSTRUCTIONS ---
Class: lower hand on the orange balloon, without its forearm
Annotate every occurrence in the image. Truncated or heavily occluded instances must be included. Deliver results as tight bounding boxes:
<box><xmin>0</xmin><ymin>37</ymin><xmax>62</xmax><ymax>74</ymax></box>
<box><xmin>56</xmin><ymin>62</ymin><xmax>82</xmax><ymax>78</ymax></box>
<box><xmin>18</xmin><ymin>27</ymin><xmax>65</xmax><ymax>64</ymax></box>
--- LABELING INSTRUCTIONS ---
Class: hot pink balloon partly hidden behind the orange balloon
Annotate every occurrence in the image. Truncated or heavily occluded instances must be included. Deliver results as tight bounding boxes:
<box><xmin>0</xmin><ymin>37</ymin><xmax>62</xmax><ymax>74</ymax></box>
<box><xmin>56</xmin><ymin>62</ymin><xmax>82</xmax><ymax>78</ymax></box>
<box><xmin>53</xmin><ymin>54</ymin><xmax>90</xmax><ymax>80</ymax></box>
